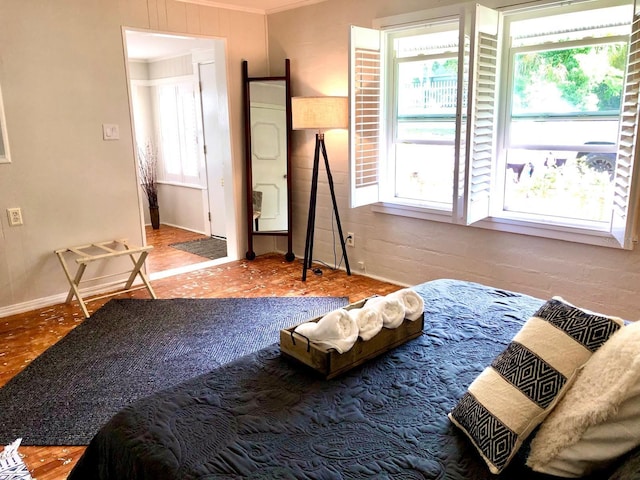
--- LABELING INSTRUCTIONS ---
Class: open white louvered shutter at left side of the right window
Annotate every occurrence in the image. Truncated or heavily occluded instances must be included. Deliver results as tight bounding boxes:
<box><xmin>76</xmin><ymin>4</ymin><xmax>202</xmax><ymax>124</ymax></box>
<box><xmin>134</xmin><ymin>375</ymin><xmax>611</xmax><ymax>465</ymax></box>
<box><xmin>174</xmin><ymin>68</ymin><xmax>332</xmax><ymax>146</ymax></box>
<box><xmin>463</xmin><ymin>5</ymin><xmax>500</xmax><ymax>225</ymax></box>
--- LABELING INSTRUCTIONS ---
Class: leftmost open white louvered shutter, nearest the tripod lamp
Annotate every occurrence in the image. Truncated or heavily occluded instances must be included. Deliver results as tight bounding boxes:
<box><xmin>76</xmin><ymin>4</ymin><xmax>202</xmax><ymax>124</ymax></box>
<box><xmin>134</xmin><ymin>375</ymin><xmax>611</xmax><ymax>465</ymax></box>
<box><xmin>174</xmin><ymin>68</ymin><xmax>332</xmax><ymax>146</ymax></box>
<box><xmin>349</xmin><ymin>26</ymin><xmax>382</xmax><ymax>208</ymax></box>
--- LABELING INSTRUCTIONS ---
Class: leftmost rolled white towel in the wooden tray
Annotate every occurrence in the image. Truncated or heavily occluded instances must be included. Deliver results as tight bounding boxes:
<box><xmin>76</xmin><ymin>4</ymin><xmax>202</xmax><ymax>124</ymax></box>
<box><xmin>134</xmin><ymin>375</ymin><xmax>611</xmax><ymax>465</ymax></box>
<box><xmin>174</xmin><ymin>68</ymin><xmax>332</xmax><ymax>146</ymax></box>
<box><xmin>294</xmin><ymin>308</ymin><xmax>358</xmax><ymax>353</ymax></box>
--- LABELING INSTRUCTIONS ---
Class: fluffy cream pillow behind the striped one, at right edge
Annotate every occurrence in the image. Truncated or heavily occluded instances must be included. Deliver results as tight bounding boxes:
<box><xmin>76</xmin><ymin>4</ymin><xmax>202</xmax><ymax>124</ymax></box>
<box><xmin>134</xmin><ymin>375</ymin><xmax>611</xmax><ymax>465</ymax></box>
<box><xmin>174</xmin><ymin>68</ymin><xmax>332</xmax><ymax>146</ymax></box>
<box><xmin>527</xmin><ymin>322</ymin><xmax>640</xmax><ymax>478</ymax></box>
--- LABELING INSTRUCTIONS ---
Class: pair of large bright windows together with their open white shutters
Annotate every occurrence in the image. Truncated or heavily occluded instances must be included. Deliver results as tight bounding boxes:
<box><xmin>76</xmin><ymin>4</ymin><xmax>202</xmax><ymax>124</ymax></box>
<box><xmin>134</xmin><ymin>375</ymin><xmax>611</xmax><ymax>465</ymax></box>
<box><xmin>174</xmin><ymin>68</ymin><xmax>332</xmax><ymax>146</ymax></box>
<box><xmin>350</xmin><ymin>0</ymin><xmax>640</xmax><ymax>248</ymax></box>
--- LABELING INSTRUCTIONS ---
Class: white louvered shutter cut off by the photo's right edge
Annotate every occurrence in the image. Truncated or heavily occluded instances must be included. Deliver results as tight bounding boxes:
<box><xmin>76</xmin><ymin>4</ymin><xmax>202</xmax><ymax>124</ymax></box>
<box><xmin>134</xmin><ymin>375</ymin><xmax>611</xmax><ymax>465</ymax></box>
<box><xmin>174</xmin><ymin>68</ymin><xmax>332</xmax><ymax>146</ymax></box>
<box><xmin>611</xmin><ymin>0</ymin><xmax>640</xmax><ymax>249</ymax></box>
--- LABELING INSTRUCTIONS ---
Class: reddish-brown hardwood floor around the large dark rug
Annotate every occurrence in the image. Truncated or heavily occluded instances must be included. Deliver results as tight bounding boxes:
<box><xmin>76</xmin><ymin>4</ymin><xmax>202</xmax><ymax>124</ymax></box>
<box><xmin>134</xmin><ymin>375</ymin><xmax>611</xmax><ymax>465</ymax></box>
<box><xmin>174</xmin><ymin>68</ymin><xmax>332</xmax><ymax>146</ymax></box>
<box><xmin>0</xmin><ymin>225</ymin><xmax>399</xmax><ymax>480</ymax></box>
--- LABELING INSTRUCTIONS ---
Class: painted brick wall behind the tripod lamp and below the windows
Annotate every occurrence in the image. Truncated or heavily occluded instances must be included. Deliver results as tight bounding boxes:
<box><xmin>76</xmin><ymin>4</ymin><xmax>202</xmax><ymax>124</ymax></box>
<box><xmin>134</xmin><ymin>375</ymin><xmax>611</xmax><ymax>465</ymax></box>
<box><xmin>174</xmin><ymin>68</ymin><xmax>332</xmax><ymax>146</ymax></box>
<box><xmin>268</xmin><ymin>0</ymin><xmax>640</xmax><ymax>320</ymax></box>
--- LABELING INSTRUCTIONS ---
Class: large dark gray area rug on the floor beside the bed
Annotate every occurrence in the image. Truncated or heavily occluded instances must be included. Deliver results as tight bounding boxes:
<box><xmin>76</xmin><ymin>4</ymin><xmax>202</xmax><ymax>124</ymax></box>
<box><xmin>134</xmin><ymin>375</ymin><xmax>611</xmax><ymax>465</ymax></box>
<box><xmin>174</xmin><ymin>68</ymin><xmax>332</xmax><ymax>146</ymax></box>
<box><xmin>0</xmin><ymin>297</ymin><xmax>347</xmax><ymax>445</ymax></box>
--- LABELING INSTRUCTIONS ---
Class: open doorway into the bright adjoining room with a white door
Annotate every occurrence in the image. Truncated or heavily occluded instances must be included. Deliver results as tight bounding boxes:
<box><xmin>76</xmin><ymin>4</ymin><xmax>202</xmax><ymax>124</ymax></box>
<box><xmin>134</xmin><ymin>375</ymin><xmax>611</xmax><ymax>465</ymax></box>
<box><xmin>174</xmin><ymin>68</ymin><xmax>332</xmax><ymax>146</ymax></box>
<box><xmin>123</xmin><ymin>29</ymin><xmax>237</xmax><ymax>278</ymax></box>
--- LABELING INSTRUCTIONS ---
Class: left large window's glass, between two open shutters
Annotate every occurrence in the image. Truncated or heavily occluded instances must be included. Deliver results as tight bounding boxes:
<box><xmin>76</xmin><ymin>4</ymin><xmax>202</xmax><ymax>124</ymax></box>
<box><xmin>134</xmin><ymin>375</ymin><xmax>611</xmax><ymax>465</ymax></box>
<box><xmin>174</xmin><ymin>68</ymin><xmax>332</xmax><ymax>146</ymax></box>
<box><xmin>396</xmin><ymin>23</ymin><xmax>459</xmax><ymax>209</ymax></box>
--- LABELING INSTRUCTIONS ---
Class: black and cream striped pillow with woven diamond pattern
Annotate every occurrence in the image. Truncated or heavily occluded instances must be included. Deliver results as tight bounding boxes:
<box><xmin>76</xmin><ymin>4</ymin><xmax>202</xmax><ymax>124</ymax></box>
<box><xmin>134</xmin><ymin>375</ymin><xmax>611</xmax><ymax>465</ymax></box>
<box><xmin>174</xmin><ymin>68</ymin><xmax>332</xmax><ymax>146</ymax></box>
<box><xmin>449</xmin><ymin>297</ymin><xmax>624</xmax><ymax>474</ymax></box>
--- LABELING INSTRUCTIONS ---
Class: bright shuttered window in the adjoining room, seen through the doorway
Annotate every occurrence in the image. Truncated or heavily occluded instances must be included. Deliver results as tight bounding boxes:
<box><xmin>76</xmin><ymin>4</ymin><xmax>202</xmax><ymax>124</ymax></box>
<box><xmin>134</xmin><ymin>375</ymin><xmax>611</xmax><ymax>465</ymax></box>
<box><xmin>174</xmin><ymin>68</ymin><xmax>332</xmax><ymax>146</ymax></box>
<box><xmin>156</xmin><ymin>80</ymin><xmax>201</xmax><ymax>185</ymax></box>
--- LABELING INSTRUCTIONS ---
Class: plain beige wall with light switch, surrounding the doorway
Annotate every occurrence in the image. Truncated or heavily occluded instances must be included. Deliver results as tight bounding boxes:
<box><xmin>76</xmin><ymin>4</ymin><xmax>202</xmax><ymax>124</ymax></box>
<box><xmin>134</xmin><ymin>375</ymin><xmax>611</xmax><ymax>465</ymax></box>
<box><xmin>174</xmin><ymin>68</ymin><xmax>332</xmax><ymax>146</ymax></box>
<box><xmin>0</xmin><ymin>0</ymin><xmax>267</xmax><ymax>316</ymax></box>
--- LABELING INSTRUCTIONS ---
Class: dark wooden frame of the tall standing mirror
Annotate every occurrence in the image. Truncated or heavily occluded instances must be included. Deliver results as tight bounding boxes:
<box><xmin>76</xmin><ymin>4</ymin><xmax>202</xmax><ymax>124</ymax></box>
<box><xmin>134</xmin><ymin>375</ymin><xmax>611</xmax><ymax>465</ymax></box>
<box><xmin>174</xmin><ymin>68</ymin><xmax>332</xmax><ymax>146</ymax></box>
<box><xmin>242</xmin><ymin>58</ymin><xmax>295</xmax><ymax>262</ymax></box>
